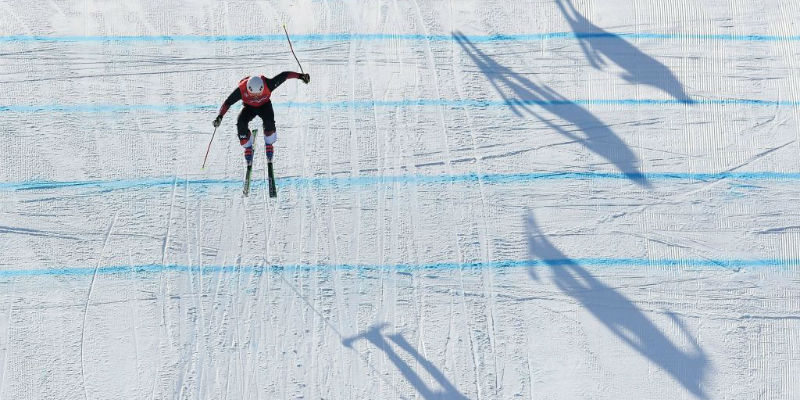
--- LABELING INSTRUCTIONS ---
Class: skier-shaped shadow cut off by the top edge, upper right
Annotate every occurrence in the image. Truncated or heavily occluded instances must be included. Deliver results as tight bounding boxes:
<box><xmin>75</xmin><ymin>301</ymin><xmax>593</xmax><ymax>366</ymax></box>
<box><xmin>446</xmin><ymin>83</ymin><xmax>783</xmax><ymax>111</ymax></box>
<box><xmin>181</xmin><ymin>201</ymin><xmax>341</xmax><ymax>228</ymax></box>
<box><xmin>555</xmin><ymin>0</ymin><xmax>692</xmax><ymax>104</ymax></box>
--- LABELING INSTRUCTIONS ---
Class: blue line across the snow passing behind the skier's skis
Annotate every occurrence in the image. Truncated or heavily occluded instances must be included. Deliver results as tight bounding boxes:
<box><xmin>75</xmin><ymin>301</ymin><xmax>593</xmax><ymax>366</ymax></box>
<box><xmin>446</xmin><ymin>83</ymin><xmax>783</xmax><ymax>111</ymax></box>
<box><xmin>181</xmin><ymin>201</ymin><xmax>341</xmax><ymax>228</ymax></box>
<box><xmin>0</xmin><ymin>171</ymin><xmax>800</xmax><ymax>192</ymax></box>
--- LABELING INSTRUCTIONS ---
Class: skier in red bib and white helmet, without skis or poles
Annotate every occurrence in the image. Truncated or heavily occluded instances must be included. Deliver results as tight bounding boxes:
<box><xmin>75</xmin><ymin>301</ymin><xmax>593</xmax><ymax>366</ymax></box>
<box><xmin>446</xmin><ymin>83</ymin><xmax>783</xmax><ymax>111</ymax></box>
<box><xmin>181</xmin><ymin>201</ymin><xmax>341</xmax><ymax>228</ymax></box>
<box><xmin>213</xmin><ymin>71</ymin><xmax>311</xmax><ymax>166</ymax></box>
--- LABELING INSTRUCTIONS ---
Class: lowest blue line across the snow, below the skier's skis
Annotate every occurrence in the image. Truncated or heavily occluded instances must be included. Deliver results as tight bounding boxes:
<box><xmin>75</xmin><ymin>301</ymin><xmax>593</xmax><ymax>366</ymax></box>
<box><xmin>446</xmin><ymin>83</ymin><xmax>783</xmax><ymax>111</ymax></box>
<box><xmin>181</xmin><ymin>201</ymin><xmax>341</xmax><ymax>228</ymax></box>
<box><xmin>0</xmin><ymin>258</ymin><xmax>800</xmax><ymax>278</ymax></box>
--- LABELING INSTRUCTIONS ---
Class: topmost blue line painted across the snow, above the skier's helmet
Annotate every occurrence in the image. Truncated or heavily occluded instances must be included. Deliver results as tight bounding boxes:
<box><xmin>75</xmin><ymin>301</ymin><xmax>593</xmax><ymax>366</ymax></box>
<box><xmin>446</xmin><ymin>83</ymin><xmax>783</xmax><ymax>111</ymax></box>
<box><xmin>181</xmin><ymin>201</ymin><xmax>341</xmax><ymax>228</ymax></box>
<box><xmin>0</xmin><ymin>32</ymin><xmax>800</xmax><ymax>43</ymax></box>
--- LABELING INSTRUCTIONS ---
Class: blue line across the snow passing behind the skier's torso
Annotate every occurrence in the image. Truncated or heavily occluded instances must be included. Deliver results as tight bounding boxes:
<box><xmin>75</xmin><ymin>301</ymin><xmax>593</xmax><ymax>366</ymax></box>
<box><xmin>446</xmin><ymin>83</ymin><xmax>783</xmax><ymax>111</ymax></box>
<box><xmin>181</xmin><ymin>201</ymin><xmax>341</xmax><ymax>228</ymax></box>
<box><xmin>0</xmin><ymin>99</ymin><xmax>800</xmax><ymax>113</ymax></box>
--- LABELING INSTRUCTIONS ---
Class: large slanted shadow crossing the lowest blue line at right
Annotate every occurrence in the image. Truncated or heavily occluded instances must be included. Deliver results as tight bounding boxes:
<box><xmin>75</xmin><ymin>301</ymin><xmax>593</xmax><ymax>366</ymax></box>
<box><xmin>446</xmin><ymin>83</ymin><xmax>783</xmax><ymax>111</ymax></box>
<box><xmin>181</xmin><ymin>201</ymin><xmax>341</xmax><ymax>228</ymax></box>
<box><xmin>525</xmin><ymin>211</ymin><xmax>709</xmax><ymax>399</ymax></box>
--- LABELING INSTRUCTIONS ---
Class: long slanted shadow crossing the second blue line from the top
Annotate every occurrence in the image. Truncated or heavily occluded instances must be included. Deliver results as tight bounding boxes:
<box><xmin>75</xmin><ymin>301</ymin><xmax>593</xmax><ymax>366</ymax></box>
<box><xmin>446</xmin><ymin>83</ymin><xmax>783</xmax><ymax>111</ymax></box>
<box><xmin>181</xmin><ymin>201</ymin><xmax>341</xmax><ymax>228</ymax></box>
<box><xmin>453</xmin><ymin>31</ymin><xmax>651</xmax><ymax>188</ymax></box>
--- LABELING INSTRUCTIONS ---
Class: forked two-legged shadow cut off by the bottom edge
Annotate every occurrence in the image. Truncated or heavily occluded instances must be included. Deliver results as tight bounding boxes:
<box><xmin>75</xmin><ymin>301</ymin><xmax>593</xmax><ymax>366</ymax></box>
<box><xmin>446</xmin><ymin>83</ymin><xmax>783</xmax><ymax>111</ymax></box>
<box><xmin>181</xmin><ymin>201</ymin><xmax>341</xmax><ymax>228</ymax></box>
<box><xmin>342</xmin><ymin>323</ymin><xmax>467</xmax><ymax>400</ymax></box>
